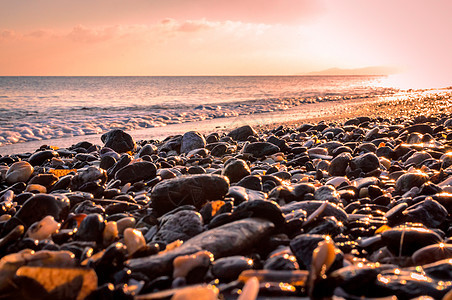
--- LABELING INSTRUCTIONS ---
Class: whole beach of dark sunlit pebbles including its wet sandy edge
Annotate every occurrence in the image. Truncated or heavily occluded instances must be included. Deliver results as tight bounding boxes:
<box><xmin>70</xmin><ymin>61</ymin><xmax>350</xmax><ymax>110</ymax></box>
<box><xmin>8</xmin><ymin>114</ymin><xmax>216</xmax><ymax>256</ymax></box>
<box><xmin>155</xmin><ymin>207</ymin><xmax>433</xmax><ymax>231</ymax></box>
<box><xmin>0</xmin><ymin>89</ymin><xmax>452</xmax><ymax>300</ymax></box>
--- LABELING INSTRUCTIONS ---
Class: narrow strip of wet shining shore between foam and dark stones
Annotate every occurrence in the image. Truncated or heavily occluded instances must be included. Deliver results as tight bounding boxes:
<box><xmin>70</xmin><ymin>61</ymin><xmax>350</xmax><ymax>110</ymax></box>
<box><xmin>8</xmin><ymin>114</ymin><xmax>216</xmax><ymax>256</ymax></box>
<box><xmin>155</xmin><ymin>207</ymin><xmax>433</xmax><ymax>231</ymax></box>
<box><xmin>0</xmin><ymin>89</ymin><xmax>452</xmax><ymax>155</ymax></box>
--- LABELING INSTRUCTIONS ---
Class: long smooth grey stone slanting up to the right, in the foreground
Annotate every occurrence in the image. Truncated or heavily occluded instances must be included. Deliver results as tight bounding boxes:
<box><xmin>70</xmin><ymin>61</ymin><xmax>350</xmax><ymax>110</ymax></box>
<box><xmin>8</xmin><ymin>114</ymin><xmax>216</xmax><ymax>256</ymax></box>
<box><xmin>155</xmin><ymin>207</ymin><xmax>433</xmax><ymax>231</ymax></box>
<box><xmin>126</xmin><ymin>218</ymin><xmax>274</xmax><ymax>278</ymax></box>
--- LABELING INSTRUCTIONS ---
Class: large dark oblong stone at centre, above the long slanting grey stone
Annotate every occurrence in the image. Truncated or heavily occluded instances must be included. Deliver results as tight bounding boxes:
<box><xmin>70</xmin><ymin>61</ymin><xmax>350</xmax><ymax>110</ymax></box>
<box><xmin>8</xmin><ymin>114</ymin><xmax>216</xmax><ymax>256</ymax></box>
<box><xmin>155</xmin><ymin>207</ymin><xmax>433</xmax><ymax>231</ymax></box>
<box><xmin>151</xmin><ymin>174</ymin><xmax>229</xmax><ymax>215</ymax></box>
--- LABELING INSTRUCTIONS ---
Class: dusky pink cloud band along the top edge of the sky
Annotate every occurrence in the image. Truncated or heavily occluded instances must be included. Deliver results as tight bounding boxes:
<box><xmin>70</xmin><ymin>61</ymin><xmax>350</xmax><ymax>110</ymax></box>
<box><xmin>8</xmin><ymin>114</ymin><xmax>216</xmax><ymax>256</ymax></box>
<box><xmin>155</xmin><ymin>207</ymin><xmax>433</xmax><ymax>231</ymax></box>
<box><xmin>0</xmin><ymin>0</ymin><xmax>325</xmax><ymax>28</ymax></box>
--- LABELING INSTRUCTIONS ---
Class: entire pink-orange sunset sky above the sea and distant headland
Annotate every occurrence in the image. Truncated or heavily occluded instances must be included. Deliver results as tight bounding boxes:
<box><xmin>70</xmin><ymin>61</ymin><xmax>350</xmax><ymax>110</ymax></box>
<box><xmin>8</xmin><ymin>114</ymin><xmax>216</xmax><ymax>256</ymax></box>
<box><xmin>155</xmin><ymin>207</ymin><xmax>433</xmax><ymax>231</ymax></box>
<box><xmin>0</xmin><ymin>0</ymin><xmax>452</xmax><ymax>86</ymax></box>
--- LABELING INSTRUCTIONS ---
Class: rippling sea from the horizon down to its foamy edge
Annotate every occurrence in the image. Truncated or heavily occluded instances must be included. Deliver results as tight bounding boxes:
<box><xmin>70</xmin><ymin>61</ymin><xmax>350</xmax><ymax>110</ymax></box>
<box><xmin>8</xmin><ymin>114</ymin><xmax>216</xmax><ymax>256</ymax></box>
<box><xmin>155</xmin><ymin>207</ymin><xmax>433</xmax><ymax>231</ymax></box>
<box><xmin>0</xmin><ymin>76</ymin><xmax>397</xmax><ymax>154</ymax></box>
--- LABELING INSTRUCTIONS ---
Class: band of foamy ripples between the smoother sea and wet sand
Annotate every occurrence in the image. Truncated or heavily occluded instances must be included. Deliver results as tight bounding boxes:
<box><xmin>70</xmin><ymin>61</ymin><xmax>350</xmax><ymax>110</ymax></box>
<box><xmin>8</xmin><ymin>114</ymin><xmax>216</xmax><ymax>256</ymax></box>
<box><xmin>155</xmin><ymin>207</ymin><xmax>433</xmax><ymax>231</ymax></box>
<box><xmin>0</xmin><ymin>92</ymin><xmax>396</xmax><ymax>147</ymax></box>
